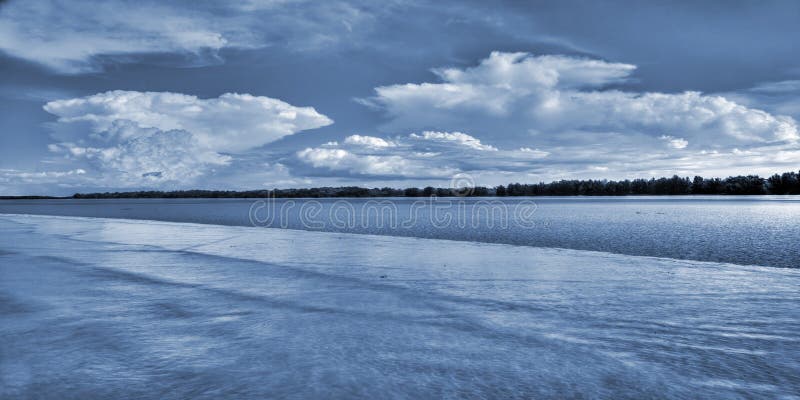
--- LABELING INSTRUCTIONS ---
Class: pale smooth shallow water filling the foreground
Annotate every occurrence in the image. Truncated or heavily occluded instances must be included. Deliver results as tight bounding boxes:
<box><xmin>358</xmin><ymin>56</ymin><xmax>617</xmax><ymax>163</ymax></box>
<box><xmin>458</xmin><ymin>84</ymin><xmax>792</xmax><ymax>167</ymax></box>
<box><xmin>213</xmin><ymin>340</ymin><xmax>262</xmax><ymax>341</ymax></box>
<box><xmin>0</xmin><ymin>215</ymin><xmax>800</xmax><ymax>399</ymax></box>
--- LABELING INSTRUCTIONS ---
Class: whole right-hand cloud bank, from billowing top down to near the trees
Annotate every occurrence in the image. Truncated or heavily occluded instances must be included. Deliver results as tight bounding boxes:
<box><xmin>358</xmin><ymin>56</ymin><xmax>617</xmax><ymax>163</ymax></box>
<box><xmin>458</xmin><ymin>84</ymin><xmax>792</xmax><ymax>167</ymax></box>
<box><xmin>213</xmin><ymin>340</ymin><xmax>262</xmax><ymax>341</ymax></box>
<box><xmin>338</xmin><ymin>52</ymin><xmax>800</xmax><ymax>184</ymax></box>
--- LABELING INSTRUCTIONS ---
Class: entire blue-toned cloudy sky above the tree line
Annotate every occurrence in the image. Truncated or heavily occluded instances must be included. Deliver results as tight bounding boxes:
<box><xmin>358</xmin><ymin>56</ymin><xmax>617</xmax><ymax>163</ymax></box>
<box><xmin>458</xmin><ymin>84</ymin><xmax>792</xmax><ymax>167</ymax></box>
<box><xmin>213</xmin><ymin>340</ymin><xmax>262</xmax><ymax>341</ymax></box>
<box><xmin>0</xmin><ymin>0</ymin><xmax>800</xmax><ymax>195</ymax></box>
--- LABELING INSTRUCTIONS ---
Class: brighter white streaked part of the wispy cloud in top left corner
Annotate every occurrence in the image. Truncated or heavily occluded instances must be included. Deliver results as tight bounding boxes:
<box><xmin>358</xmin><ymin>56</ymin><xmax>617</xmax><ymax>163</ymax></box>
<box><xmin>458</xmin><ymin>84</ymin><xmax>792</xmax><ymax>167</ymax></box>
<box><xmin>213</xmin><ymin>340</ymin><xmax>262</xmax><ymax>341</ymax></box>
<box><xmin>0</xmin><ymin>0</ymin><xmax>234</xmax><ymax>73</ymax></box>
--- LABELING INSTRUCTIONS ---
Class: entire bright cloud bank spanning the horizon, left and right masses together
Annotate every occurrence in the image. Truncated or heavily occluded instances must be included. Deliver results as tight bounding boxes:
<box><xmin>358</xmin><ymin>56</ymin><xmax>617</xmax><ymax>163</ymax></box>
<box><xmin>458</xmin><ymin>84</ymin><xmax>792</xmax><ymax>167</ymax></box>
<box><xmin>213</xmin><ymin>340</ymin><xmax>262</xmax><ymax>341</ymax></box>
<box><xmin>7</xmin><ymin>52</ymin><xmax>800</xmax><ymax>194</ymax></box>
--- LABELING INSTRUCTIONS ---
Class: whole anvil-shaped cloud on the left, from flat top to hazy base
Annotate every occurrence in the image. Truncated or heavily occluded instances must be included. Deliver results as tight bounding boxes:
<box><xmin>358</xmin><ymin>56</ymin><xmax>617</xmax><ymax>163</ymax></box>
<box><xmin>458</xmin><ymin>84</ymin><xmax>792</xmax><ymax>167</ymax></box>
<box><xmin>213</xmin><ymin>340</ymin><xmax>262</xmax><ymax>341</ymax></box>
<box><xmin>44</xmin><ymin>91</ymin><xmax>332</xmax><ymax>186</ymax></box>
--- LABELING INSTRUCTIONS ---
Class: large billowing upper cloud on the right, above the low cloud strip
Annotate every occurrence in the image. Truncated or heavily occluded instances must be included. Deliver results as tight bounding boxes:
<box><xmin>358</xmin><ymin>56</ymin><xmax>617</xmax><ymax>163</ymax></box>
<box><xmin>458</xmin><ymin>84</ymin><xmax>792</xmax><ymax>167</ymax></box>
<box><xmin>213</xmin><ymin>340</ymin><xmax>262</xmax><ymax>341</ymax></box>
<box><xmin>362</xmin><ymin>52</ymin><xmax>800</xmax><ymax>146</ymax></box>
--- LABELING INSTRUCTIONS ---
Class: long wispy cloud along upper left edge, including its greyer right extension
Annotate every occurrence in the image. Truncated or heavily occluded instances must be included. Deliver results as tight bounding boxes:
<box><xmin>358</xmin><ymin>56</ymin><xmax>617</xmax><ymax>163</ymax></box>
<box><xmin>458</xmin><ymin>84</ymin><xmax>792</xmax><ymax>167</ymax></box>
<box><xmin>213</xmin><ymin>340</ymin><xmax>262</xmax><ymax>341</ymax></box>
<box><xmin>0</xmin><ymin>0</ymin><xmax>370</xmax><ymax>74</ymax></box>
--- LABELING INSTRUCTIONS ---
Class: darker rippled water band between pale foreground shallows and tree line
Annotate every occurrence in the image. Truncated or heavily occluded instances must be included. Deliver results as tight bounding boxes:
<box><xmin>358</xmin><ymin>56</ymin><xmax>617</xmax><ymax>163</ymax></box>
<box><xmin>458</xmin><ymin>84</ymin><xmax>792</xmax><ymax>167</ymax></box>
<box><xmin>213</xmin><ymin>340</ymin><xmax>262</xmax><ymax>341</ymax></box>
<box><xmin>0</xmin><ymin>196</ymin><xmax>800</xmax><ymax>268</ymax></box>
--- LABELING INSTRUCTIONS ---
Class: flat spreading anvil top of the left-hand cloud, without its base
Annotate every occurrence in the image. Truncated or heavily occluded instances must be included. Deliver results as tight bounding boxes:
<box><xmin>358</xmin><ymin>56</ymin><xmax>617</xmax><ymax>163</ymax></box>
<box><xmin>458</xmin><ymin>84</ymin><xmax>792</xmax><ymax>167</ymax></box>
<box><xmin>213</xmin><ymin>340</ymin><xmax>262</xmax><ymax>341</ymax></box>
<box><xmin>44</xmin><ymin>90</ymin><xmax>333</xmax><ymax>152</ymax></box>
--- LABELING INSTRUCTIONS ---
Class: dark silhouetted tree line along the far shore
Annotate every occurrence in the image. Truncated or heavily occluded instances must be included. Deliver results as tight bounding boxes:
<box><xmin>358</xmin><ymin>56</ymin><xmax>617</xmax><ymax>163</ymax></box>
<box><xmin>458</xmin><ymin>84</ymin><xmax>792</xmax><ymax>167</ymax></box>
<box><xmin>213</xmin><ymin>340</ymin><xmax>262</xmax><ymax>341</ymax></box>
<box><xmin>67</xmin><ymin>172</ymin><xmax>800</xmax><ymax>199</ymax></box>
